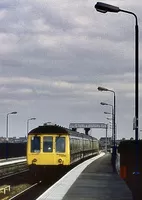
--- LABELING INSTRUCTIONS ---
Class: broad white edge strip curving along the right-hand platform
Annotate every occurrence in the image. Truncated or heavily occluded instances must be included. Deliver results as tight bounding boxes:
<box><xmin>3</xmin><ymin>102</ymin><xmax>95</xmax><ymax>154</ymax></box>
<box><xmin>37</xmin><ymin>153</ymin><xmax>105</xmax><ymax>200</ymax></box>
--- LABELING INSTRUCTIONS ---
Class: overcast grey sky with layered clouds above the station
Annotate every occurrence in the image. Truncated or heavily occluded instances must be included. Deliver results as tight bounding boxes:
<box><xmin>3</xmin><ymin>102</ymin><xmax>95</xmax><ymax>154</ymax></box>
<box><xmin>0</xmin><ymin>0</ymin><xmax>142</xmax><ymax>138</ymax></box>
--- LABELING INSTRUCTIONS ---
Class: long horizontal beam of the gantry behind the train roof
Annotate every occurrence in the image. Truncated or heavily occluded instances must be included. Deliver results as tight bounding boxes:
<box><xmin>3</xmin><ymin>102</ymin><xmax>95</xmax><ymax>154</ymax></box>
<box><xmin>69</xmin><ymin>123</ymin><xmax>107</xmax><ymax>129</ymax></box>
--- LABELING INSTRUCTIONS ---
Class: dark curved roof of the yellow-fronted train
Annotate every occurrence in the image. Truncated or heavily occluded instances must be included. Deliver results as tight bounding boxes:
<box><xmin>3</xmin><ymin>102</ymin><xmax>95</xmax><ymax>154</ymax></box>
<box><xmin>28</xmin><ymin>125</ymin><xmax>97</xmax><ymax>140</ymax></box>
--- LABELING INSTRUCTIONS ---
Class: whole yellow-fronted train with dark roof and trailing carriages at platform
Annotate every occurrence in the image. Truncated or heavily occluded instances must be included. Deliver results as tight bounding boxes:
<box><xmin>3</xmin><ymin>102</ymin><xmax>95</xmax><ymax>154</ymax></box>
<box><xmin>27</xmin><ymin>125</ymin><xmax>99</xmax><ymax>177</ymax></box>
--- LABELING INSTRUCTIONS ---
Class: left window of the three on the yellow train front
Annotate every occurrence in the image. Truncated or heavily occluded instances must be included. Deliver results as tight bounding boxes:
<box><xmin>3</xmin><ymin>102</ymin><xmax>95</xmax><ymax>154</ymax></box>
<box><xmin>31</xmin><ymin>136</ymin><xmax>40</xmax><ymax>153</ymax></box>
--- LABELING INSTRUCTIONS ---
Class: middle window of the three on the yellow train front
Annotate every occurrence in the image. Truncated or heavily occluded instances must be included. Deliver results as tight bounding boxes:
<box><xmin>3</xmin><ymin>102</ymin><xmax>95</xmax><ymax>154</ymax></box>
<box><xmin>43</xmin><ymin>136</ymin><xmax>53</xmax><ymax>152</ymax></box>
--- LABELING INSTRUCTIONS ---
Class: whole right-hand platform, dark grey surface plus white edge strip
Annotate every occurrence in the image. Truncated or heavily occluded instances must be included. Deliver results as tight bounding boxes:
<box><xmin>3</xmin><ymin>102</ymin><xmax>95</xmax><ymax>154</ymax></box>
<box><xmin>37</xmin><ymin>153</ymin><xmax>133</xmax><ymax>200</ymax></box>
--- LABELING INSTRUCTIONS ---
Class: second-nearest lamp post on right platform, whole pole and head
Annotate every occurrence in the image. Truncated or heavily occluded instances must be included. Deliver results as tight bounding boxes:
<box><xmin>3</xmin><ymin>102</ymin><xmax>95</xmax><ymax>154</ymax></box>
<box><xmin>98</xmin><ymin>87</ymin><xmax>116</xmax><ymax>171</ymax></box>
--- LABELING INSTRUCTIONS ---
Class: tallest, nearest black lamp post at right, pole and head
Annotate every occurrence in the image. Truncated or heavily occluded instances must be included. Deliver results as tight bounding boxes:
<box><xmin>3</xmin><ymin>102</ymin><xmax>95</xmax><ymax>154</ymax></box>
<box><xmin>95</xmin><ymin>2</ymin><xmax>139</xmax><ymax>174</ymax></box>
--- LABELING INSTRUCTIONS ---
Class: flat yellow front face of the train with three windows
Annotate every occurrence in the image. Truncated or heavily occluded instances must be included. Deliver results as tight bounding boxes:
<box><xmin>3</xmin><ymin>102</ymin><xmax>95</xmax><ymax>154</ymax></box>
<box><xmin>27</xmin><ymin>134</ymin><xmax>70</xmax><ymax>165</ymax></box>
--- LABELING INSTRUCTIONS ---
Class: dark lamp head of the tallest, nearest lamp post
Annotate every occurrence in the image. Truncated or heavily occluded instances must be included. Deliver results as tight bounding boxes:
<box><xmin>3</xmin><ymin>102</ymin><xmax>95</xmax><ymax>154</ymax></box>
<box><xmin>95</xmin><ymin>2</ymin><xmax>120</xmax><ymax>13</ymax></box>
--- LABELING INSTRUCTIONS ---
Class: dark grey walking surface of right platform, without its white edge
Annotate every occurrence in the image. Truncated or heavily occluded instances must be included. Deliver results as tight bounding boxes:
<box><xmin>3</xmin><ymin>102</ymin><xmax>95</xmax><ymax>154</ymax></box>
<box><xmin>63</xmin><ymin>154</ymin><xmax>133</xmax><ymax>200</ymax></box>
